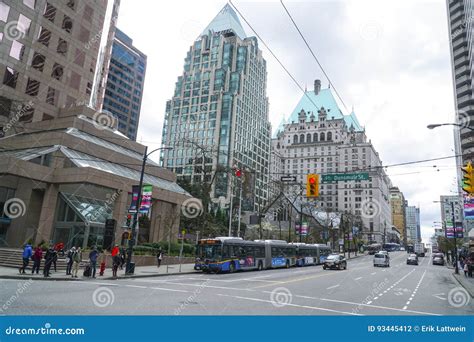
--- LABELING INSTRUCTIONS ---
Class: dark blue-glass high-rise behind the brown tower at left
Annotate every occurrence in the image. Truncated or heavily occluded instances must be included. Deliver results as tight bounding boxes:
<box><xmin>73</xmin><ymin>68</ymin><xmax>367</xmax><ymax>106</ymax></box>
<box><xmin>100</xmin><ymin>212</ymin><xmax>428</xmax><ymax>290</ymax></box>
<box><xmin>103</xmin><ymin>29</ymin><xmax>147</xmax><ymax>140</ymax></box>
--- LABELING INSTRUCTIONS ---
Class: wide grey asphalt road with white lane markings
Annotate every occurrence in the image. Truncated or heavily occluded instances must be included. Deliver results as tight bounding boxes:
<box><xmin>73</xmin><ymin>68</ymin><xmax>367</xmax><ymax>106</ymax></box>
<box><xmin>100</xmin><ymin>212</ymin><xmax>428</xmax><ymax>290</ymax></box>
<box><xmin>0</xmin><ymin>252</ymin><xmax>474</xmax><ymax>315</ymax></box>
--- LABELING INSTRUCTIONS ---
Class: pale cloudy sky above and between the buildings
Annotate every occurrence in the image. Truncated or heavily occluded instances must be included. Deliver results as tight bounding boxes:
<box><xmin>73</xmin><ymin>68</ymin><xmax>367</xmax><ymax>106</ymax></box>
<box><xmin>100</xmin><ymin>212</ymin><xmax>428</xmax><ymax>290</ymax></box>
<box><xmin>118</xmin><ymin>0</ymin><xmax>456</xmax><ymax>242</ymax></box>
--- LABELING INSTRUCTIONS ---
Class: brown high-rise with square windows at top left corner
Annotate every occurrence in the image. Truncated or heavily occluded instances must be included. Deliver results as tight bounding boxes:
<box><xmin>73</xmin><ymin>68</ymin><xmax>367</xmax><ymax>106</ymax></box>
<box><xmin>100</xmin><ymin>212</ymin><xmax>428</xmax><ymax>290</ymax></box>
<box><xmin>0</xmin><ymin>0</ymin><xmax>120</xmax><ymax>123</ymax></box>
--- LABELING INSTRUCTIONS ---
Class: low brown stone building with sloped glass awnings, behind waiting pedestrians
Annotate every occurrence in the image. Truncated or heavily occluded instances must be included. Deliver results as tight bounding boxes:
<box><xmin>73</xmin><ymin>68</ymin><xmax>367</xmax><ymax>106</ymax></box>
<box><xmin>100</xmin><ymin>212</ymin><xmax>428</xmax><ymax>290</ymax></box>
<box><xmin>0</xmin><ymin>106</ymin><xmax>189</xmax><ymax>247</ymax></box>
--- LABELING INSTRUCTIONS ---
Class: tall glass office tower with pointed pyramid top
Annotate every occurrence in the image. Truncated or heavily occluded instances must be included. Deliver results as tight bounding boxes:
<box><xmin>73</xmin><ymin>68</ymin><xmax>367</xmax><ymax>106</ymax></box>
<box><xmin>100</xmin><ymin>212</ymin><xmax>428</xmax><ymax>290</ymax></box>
<box><xmin>161</xmin><ymin>4</ymin><xmax>270</xmax><ymax>211</ymax></box>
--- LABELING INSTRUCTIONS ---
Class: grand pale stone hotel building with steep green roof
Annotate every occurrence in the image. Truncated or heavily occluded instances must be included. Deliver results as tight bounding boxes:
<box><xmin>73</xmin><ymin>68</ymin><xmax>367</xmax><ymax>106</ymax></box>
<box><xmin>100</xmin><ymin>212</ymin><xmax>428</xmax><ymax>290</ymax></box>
<box><xmin>270</xmin><ymin>80</ymin><xmax>392</xmax><ymax>242</ymax></box>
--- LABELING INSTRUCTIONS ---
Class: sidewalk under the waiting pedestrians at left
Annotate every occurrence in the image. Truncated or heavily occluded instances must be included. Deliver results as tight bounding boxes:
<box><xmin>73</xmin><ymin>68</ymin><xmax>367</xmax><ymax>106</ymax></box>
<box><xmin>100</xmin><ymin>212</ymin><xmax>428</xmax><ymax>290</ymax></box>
<box><xmin>0</xmin><ymin>264</ymin><xmax>198</xmax><ymax>281</ymax></box>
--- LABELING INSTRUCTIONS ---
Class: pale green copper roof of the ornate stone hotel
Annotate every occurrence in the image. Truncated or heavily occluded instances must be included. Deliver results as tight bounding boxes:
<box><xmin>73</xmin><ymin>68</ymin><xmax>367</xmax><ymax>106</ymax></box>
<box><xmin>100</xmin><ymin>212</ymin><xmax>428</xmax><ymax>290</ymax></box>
<box><xmin>273</xmin><ymin>88</ymin><xmax>364</xmax><ymax>137</ymax></box>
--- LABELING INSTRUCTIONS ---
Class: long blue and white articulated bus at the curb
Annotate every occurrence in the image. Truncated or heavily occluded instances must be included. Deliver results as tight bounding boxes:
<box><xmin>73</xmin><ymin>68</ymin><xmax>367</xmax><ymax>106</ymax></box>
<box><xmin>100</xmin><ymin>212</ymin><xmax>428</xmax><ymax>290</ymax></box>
<box><xmin>194</xmin><ymin>237</ymin><xmax>331</xmax><ymax>273</ymax></box>
